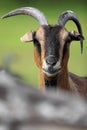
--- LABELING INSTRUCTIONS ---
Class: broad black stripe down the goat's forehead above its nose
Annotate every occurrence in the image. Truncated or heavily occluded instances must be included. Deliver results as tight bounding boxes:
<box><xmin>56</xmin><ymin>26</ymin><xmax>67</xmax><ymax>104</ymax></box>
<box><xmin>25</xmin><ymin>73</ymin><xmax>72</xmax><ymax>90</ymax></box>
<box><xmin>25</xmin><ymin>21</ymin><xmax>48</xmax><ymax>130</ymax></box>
<box><xmin>44</xmin><ymin>26</ymin><xmax>61</xmax><ymax>57</ymax></box>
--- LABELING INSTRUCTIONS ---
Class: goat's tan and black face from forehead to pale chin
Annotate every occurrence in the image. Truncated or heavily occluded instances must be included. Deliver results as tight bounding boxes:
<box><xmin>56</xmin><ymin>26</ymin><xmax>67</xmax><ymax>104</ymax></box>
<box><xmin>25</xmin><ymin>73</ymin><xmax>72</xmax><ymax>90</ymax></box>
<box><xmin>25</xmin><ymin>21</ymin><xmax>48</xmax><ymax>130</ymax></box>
<box><xmin>22</xmin><ymin>25</ymin><xmax>70</xmax><ymax>76</ymax></box>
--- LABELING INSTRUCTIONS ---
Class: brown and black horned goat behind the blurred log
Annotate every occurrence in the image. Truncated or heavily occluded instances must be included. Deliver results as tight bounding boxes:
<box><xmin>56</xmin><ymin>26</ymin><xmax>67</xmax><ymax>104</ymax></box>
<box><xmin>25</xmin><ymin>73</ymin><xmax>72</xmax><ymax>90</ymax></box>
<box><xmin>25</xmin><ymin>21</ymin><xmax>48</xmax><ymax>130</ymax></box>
<box><xmin>2</xmin><ymin>7</ymin><xmax>87</xmax><ymax>96</ymax></box>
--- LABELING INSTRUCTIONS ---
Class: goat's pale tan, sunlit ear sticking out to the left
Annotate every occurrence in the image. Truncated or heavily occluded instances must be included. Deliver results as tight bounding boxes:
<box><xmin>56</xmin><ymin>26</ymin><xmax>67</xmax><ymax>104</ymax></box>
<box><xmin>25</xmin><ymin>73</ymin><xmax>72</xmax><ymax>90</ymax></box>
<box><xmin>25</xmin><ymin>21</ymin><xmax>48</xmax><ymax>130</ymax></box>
<box><xmin>20</xmin><ymin>31</ymin><xmax>34</xmax><ymax>42</ymax></box>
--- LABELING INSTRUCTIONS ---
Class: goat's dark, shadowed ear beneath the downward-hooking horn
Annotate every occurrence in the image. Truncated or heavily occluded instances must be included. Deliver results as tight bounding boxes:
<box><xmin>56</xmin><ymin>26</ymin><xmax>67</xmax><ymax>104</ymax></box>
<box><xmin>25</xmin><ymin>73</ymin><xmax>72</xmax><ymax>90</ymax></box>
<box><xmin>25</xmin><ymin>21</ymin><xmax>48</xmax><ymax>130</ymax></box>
<box><xmin>69</xmin><ymin>31</ymin><xmax>84</xmax><ymax>41</ymax></box>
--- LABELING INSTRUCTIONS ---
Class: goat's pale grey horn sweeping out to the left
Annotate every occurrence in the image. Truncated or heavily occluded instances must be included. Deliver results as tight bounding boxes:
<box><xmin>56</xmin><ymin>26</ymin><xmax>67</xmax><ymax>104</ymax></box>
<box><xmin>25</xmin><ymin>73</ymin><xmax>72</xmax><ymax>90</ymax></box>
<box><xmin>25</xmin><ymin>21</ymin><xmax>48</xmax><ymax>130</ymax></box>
<box><xmin>2</xmin><ymin>7</ymin><xmax>48</xmax><ymax>25</ymax></box>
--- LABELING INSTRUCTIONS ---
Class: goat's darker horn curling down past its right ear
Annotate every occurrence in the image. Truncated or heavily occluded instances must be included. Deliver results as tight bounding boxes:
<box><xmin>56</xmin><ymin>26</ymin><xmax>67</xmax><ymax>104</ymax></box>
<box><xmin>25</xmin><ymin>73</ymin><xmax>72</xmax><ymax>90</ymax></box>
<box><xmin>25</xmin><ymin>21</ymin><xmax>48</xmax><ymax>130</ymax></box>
<box><xmin>58</xmin><ymin>10</ymin><xmax>83</xmax><ymax>53</ymax></box>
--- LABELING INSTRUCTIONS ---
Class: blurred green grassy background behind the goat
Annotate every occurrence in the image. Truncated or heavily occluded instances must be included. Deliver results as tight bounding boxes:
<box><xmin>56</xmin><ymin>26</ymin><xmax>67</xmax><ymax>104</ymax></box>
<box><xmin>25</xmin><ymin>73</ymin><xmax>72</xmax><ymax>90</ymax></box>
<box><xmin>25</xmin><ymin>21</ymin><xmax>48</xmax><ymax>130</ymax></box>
<box><xmin>0</xmin><ymin>0</ymin><xmax>87</xmax><ymax>85</ymax></box>
